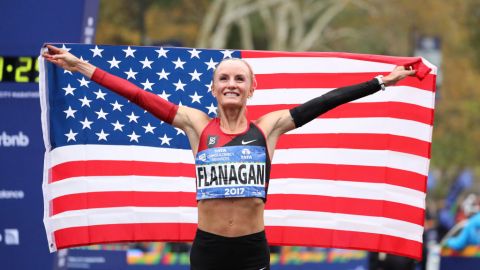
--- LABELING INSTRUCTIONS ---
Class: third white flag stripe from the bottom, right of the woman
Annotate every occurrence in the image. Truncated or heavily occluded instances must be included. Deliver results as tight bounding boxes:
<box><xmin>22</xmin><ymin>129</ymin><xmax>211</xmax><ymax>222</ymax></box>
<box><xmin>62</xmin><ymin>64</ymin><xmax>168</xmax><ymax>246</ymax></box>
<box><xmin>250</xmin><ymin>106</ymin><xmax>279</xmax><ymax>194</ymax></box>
<box><xmin>272</xmin><ymin>148</ymin><xmax>430</xmax><ymax>175</ymax></box>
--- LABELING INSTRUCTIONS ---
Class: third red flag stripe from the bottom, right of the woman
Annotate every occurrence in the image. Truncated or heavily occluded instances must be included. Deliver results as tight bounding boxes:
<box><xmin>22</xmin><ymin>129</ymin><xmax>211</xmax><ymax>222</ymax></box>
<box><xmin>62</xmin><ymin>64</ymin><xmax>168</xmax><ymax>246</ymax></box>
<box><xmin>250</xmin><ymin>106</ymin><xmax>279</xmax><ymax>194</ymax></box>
<box><xmin>270</xmin><ymin>164</ymin><xmax>427</xmax><ymax>192</ymax></box>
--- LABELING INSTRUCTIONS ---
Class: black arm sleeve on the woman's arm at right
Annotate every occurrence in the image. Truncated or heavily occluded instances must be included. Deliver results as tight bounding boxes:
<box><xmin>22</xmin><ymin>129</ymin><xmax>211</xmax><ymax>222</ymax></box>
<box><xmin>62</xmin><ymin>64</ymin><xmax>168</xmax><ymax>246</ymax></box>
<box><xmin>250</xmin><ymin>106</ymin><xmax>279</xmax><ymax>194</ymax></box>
<box><xmin>290</xmin><ymin>79</ymin><xmax>381</xmax><ymax>128</ymax></box>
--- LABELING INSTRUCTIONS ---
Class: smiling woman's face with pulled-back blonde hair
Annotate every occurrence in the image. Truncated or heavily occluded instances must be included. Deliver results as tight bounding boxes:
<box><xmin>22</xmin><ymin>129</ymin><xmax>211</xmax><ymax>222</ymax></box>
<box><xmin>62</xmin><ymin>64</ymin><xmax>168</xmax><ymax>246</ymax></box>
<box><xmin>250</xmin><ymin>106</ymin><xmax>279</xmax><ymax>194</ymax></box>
<box><xmin>212</xmin><ymin>59</ymin><xmax>253</xmax><ymax>107</ymax></box>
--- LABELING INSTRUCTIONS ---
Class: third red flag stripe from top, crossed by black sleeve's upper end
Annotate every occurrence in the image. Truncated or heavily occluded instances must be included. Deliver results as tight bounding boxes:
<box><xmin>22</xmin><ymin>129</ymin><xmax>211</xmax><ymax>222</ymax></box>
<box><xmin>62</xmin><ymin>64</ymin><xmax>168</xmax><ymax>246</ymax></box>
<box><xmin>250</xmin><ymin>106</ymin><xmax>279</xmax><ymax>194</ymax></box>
<box><xmin>248</xmin><ymin>102</ymin><xmax>433</xmax><ymax>125</ymax></box>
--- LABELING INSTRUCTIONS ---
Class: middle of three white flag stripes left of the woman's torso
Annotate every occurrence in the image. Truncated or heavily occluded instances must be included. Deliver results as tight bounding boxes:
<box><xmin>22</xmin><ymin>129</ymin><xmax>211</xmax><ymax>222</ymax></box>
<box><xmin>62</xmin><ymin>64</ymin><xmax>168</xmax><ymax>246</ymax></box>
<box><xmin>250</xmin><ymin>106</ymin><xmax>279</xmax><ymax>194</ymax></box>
<box><xmin>48</xmin><ymin>175</ymin><xmax>195</xmax><ymax>200</ymax></box>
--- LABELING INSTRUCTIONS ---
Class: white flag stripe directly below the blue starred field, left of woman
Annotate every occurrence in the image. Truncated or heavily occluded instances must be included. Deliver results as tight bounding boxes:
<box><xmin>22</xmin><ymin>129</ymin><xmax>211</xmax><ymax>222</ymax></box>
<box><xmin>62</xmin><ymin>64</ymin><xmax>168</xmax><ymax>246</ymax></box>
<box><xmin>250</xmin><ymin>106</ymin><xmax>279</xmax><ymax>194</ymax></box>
<box><xmin>50</xmin><ymin>145</ymin><xmax>194</xmax><ymax>167</ymax></box>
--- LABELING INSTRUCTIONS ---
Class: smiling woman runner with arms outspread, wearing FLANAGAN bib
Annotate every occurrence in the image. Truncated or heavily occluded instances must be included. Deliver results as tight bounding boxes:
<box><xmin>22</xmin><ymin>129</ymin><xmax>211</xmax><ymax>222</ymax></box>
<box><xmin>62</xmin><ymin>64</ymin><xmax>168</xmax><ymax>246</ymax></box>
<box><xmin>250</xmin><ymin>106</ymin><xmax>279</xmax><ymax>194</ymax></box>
<box><xmin>43</xmin><ymin>45</ymin><xmax>415</xmax><ymax>270</ymax></box>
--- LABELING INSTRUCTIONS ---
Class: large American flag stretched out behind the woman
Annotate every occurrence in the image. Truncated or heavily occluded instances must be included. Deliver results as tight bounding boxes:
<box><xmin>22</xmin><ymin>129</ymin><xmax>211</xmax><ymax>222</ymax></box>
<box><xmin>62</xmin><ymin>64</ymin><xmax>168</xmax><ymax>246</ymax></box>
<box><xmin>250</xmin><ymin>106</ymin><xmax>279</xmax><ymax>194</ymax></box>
<box><xmin>40</xmin><ymin>44</ymin><xmax>436</xmax><ymax>259</ymax></box>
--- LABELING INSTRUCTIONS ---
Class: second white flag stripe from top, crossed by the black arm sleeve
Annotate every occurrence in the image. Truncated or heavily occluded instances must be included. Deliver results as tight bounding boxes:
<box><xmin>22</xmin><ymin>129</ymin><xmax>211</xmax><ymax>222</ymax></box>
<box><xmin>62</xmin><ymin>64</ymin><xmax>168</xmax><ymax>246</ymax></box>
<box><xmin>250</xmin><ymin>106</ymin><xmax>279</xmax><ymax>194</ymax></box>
<box><xmin>248</xmin><ymin>86</ymin><xmax>435</xmax><ymax>109</ymax></box>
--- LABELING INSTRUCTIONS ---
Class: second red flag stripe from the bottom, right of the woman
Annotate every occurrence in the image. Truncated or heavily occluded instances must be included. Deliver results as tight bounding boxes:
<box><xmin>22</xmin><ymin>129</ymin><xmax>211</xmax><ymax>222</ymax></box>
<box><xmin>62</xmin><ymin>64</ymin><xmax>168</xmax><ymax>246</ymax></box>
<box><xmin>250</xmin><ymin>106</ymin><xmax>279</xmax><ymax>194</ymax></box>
<box><xmin>265</xmin><ymin>194</ymin><xmax>424</xmax><ymax>226</ymax></box>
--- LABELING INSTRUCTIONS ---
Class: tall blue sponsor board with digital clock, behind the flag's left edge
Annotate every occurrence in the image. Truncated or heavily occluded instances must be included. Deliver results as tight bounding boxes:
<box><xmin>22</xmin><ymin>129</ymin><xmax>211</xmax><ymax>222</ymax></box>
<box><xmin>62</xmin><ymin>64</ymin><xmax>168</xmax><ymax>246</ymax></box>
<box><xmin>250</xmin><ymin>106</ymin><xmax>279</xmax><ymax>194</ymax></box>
<box><xmin>0</xmin><ymin>0</ymin><xmax>99</xmax><ymax>270</ymax></box>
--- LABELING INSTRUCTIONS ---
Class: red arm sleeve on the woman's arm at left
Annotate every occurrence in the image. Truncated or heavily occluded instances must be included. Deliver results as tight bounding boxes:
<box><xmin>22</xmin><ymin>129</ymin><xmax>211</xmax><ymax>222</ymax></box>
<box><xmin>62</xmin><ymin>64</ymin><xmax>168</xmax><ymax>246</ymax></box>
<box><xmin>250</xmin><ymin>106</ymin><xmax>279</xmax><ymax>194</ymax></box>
<box><xmin>92</xmin><ymin>68</ymin><xmax>178</xmax><ymax>124</ymax></box>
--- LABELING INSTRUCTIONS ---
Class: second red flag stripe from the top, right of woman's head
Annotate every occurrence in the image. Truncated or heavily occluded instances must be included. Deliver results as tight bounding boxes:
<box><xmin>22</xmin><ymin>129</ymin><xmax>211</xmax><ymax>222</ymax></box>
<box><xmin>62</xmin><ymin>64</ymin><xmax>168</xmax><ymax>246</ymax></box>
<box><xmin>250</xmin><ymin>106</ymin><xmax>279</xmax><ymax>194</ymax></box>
<box><xmin>255</xmin><ymin>72</ymin><xmax>435</xmax><ymax>92</ymax></box>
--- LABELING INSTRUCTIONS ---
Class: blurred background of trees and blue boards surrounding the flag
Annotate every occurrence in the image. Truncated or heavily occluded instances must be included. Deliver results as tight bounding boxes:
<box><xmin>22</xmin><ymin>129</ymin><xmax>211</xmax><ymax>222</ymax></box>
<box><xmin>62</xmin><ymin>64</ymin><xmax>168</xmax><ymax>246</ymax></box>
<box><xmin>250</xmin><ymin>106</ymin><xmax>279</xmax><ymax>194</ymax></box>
<box><xmin>0</xmin><ymin>0</ymin><xmax>480</xmax><ymax>269</ymax></box>
